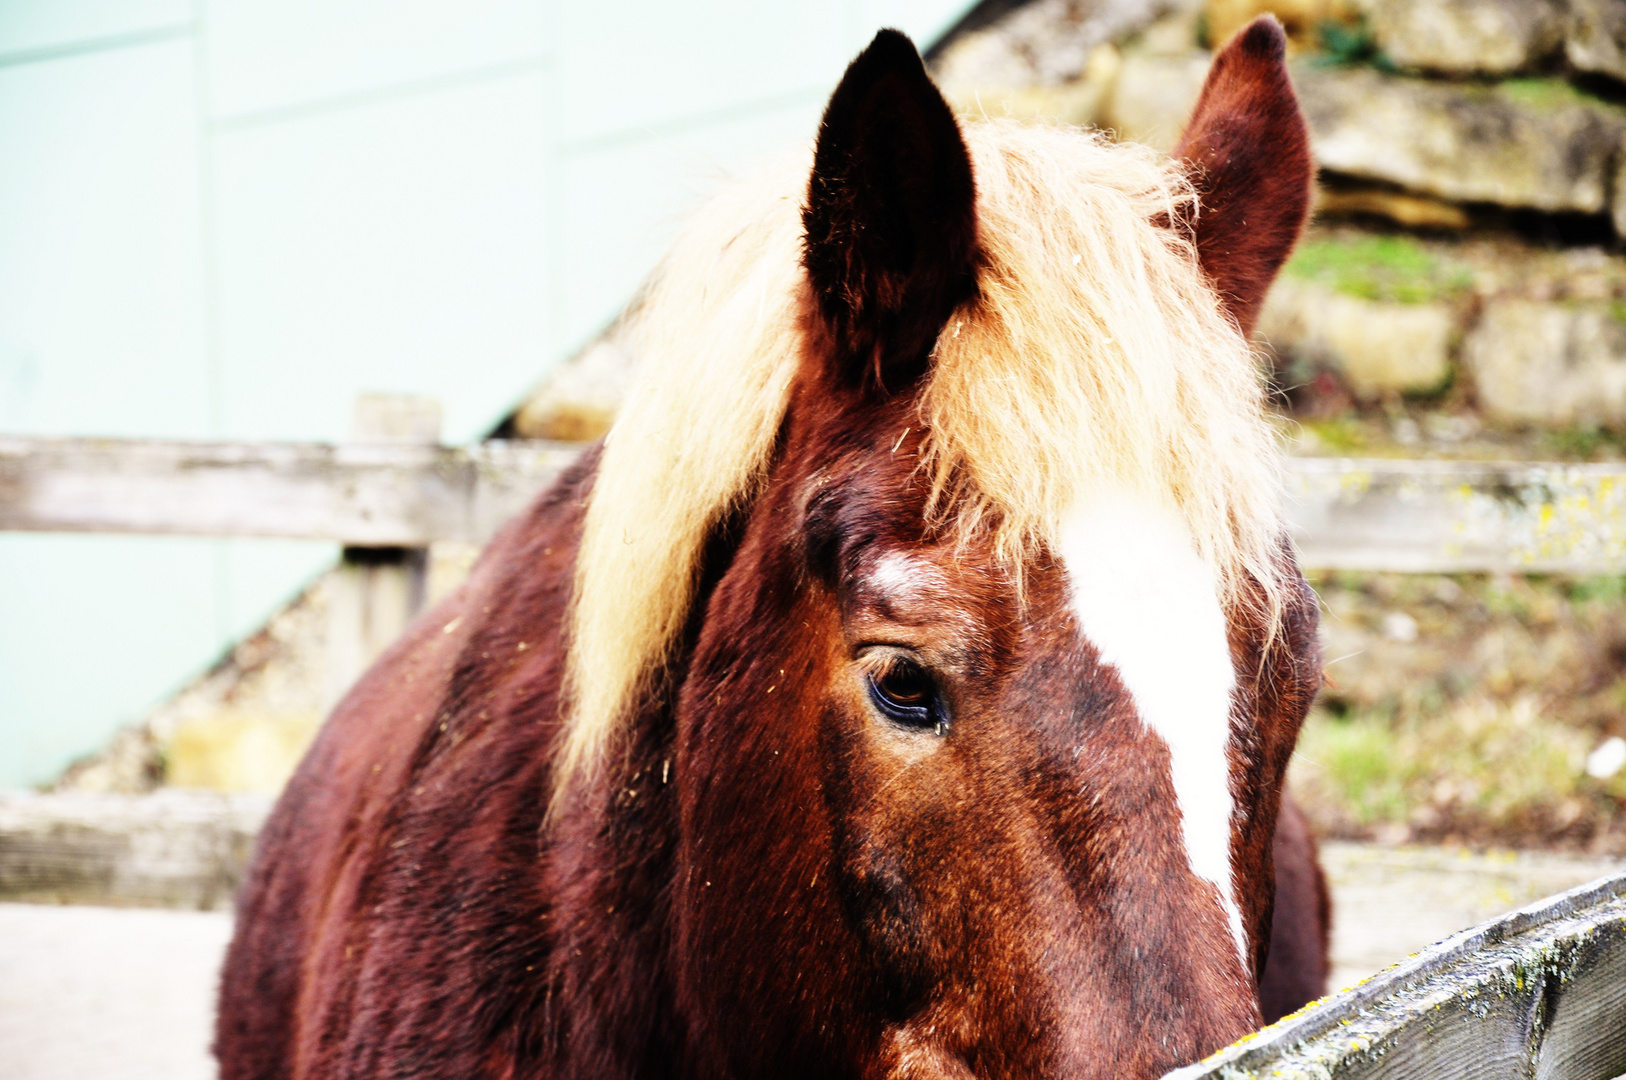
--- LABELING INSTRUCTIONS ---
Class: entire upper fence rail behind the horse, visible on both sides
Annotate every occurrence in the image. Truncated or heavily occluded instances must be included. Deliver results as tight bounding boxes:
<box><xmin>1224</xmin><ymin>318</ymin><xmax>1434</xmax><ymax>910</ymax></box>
<box><xmin>9</xmin><ymin>438</ymin><xmax>1626</xmax><ymax>574</ymax></box>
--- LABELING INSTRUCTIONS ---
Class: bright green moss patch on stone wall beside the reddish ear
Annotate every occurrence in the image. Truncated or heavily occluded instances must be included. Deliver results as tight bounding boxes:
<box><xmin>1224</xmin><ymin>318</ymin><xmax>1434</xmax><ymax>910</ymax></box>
<box><xmin>1286</xmin><ymin>234</ymin><xmax>1473</xmax><ymax>304</ymax></box>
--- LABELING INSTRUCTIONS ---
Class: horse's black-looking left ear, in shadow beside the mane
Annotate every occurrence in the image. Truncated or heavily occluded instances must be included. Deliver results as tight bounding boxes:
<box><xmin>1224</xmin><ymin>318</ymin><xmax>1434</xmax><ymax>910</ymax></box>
<box><xmin>802</xmin><ymin>29</ymin><xmax>977</xmax><ymax>389</ymax></box>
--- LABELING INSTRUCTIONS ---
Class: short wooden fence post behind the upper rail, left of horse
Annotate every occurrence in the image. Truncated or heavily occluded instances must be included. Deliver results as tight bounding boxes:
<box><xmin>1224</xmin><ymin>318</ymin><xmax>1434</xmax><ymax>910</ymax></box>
<box><xmin>324</xmin><ymin>394</ymin><xmax>441</xmax><ymax>709</ymax></box>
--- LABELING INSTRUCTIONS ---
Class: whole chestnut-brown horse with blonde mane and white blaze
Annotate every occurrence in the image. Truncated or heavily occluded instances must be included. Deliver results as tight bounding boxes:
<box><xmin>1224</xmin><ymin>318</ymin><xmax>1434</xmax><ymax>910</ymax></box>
<box><xmin>216</xmin><ymin>21</ymin><xmax>1325</xmax><ymax>1080</ymax></box>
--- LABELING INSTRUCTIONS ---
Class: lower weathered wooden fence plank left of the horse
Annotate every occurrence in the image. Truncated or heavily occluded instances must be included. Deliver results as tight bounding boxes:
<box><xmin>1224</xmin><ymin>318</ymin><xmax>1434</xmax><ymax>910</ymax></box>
<box><xmin>0</xmin><ymin>790</ymin><xmax>272</xmax><ymax>908</ymax></box>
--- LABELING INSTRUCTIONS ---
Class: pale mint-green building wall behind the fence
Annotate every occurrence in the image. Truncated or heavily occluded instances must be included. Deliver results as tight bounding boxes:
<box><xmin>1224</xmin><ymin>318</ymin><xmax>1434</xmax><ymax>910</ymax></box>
<box><xmin>0</xmin><ymin>0</ymin><xmax>969</xmax><ymax>787</ymax></box>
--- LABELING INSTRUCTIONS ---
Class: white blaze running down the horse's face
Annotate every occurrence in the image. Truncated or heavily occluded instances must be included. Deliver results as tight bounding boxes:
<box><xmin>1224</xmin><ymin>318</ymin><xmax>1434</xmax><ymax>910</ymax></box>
<box><xmin>1060</xmin><ymin>491</ymin><xmax>1250</xmax><ymax>969</ymax></box>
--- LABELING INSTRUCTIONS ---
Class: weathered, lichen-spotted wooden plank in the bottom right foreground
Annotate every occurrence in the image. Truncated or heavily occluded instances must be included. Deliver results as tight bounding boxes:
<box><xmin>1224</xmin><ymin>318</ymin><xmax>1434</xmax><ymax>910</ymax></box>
<box><xmin>1164</xmin><ymin>875</ymin><xmax>1626</xmax><ymax>1080</ymax></box>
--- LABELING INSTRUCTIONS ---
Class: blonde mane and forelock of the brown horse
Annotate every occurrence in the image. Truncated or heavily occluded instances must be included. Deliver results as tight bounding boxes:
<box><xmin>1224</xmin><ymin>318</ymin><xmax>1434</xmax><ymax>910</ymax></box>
<box><xmin>554</xmin><ymin>120</ymin><xmax>1281</xmax><ymax>792</ymax></box>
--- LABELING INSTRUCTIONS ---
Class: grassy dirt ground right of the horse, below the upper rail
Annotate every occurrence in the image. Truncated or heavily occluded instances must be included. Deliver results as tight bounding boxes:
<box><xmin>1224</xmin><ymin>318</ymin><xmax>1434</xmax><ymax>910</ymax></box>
<box><xmin>1289</xmin><ymin>573</ymin><xmax>1626</xmax><ymax>854</ymax></box>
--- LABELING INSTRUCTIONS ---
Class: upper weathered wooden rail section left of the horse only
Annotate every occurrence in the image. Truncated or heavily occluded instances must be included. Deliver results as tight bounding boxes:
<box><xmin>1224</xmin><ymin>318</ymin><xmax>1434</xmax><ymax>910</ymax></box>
<box><xmin>0</xmin><ymin>438</ymin><xmax>580</xmax><ymax>547</ymax></box>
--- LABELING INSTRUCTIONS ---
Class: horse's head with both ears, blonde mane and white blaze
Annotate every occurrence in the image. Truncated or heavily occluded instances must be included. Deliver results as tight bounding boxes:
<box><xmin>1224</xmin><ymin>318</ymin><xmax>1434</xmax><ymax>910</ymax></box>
<box><xmin>566</xmin><ymin>21</ymin><xmax>1319</xmax><ymax>1078</ymax></box>
